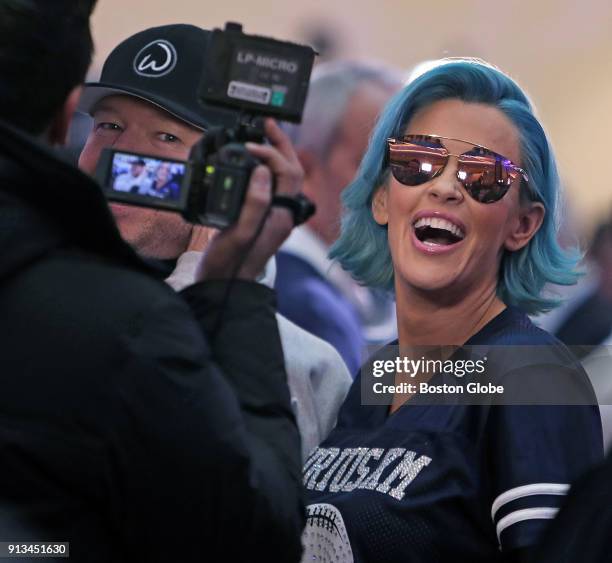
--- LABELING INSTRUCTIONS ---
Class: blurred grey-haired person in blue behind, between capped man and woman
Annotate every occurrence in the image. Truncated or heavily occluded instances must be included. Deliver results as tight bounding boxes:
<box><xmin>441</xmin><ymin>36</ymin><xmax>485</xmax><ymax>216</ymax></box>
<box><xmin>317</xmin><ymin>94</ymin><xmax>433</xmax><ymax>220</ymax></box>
<box><xmin>276</xmin><ymin>62</ymin><xmax>402</xmax><ymax>376</ymax></box>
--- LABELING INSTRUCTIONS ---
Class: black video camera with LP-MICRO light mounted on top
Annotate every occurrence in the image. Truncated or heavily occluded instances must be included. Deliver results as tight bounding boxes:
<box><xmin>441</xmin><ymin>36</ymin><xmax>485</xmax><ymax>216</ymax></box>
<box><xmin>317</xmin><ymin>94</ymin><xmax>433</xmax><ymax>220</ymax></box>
<box><xmin>96</xmin><ymin>23</ymin><xmax>316</xmax><ymax>229</ymax></box>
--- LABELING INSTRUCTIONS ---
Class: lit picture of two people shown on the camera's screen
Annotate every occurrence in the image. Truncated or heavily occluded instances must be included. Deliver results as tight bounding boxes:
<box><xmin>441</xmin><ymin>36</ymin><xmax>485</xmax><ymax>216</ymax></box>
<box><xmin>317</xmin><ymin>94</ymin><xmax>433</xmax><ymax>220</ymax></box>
<box><xmin>111</xmin><ymin>152</ymin><xmax>185</xmax><ymax>202</ymax></box>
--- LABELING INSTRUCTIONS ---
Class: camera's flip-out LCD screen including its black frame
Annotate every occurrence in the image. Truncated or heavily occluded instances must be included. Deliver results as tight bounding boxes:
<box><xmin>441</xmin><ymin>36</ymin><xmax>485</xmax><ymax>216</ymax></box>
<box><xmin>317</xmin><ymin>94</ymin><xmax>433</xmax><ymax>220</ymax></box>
<box><xmin>99</xmin><ymin>151</ymin><xmax>189</xmax><ymax>211</ymax></box>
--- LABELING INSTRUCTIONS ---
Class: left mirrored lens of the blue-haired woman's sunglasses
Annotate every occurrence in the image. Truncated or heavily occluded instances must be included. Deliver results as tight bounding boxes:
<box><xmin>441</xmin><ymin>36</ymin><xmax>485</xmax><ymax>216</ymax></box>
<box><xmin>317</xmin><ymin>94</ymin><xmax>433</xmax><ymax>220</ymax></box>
<box><xmin>389</xmin><ymin>142</ymin><xmax>447</xmax><ymax>186</ymax></box>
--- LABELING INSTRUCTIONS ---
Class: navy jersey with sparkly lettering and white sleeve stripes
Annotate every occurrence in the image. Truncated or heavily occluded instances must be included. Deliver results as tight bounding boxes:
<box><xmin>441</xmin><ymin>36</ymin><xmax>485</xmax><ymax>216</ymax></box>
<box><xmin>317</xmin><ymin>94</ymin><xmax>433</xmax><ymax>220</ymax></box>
<box><xmin>304</xmin><ymin>308</ymin><xmax>603</xmax><ymax>563</ymax></box>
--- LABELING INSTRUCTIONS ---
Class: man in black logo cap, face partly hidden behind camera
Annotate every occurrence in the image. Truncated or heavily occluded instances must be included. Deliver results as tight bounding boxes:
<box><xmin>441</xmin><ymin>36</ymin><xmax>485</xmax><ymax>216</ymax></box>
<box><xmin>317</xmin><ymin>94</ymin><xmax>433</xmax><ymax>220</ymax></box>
<box><xmin>79</xmin><ymin>24</ymin><xmax>351</xmax><ymax>458</ymax></box>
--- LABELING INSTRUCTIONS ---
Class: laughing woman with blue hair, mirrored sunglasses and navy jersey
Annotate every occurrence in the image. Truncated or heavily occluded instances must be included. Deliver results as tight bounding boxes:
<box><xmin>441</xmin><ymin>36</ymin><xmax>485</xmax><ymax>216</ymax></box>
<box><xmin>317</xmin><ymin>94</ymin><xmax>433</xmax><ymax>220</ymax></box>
<box><xmin>304</xmin><ymin>59</ymin><xmax>602</xmax><ymax>563</ymax></box>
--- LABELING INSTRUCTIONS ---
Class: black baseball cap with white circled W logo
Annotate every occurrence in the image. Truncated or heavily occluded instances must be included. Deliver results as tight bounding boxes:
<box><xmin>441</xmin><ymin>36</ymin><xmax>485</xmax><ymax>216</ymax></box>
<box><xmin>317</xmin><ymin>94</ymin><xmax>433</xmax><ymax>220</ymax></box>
<box><xmin>79</xmin><ymin>24</ymin><xmax>237</xmax><ymax>129</ymax></box>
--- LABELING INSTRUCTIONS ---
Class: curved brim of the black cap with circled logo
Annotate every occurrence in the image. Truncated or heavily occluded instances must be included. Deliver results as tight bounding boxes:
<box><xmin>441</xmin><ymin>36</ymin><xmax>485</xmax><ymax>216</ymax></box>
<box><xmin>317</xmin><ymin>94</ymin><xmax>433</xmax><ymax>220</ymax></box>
<box><xmin>77</xmin><ymin>82</ymin><xmax>227</xmax><ymax>130</ymax></box>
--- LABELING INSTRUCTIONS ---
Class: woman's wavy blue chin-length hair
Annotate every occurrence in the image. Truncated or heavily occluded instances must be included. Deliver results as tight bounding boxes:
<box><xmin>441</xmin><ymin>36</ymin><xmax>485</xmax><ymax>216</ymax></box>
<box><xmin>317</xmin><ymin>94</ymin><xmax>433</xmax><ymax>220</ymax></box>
<box><xmin>330</xmin><ymin>60</ymin><xmax>581</xmax><ymax>314</ymax></box>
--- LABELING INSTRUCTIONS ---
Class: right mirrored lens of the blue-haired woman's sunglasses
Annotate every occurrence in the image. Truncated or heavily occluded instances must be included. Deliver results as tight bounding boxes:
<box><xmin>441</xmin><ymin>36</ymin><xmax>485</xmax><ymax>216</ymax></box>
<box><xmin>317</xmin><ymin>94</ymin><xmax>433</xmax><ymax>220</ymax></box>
<box><xmin>457</xmin><ymin>153</ymin><xmax>516</xmax><ymax>203</ymax></box>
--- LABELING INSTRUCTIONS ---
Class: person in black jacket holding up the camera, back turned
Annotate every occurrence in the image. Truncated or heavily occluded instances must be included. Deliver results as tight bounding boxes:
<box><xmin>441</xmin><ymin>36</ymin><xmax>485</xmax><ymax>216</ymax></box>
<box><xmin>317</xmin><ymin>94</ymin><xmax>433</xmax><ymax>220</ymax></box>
<box><xmin>0</xmin><ymin>0</ymin><xmax>303</xmax><ymax>563</ymax></box>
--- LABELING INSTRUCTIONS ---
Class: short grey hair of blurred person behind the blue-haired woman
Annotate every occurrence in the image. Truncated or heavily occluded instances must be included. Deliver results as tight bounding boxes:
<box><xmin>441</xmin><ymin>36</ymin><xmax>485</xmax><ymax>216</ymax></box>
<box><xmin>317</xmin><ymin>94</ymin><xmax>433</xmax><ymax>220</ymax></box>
<box><xmin>285</xmin><ymin>61</ymin><xmax>405</xmax><ymax>161</ymax></box>
